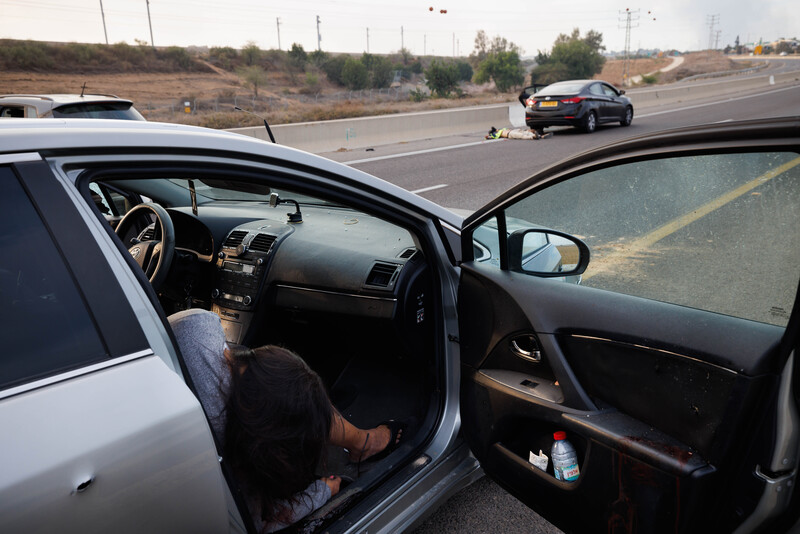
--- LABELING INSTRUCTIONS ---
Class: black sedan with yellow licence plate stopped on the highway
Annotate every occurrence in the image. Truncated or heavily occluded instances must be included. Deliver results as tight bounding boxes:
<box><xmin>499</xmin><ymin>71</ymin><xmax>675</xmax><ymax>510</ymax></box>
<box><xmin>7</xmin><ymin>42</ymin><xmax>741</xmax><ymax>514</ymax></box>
<box><xmin>519</xmin><ymin>80</ymin><xmax>633</xmax><ymax>133</ymax></box>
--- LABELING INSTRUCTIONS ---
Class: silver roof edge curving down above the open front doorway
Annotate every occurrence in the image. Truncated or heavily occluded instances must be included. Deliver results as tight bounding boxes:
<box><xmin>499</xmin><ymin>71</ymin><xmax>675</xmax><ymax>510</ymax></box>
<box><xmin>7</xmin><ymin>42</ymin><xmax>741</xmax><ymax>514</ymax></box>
<box><xmin>0</xmin><ymin>119</ymin><xmax>463</xmax><ymax>229</ymax></box>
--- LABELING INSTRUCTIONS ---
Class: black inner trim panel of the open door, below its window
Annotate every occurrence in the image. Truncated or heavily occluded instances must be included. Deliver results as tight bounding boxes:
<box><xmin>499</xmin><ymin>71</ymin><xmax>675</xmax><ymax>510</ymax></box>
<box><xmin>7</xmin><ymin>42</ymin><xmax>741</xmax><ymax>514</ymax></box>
<box><xmin>459</xmin><ymin>241</ymin><xmax>784</xmax><ymax>532</ymax></box>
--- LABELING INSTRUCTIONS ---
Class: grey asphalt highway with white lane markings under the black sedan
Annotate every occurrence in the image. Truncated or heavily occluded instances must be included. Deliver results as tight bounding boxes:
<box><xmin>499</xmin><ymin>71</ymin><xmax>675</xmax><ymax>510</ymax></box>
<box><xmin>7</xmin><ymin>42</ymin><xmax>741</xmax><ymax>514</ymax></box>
<box><xmin>318</xmin><ymin>74</ymin><xmax>800</xmax><ymax>534</ymax></box>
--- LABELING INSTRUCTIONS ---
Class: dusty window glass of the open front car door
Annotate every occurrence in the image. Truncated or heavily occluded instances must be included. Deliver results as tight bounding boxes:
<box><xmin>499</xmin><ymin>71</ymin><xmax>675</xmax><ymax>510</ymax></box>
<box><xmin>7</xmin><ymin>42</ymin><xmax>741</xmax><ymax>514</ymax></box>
<box><xmin>484</xmin><ymin>152</ymin><xmax>800</xmax><ymax>326</ymax></box>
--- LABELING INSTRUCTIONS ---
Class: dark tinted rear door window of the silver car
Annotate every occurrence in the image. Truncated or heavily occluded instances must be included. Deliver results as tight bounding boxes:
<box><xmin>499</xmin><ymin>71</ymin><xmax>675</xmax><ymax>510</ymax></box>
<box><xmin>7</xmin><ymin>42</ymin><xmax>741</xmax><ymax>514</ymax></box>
<box><xmin>0</xmin><ymin>167</ymin><xmax>107</xmax><ymax>389</ymax></box>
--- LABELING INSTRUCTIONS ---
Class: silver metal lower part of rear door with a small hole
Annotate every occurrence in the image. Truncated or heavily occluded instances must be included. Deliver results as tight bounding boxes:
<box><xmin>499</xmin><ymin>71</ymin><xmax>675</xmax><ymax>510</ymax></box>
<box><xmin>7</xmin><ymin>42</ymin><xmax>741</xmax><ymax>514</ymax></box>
<box><xmin>0</xmin><ymin>355</ymin><xmax>228</xmax><ymax>532</ymax></box>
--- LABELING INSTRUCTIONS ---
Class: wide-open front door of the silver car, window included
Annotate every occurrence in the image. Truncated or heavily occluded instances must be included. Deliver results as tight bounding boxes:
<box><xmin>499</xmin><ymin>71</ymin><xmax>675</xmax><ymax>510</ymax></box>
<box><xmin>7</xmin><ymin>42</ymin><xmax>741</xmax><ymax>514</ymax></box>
<box><xmin>458</xmin><ymin>119</ymin><xmax>800</xmax><ymax>532</ymax></box>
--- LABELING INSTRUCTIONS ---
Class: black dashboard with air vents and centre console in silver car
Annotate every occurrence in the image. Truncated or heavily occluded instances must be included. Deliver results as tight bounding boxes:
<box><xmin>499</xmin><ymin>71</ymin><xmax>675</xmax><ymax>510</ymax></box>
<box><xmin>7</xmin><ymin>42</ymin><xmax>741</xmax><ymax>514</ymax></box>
<box><xmin>161</xmin><ymin>202</ymin><xmax>431</xmax><ymax>344</ymax></box>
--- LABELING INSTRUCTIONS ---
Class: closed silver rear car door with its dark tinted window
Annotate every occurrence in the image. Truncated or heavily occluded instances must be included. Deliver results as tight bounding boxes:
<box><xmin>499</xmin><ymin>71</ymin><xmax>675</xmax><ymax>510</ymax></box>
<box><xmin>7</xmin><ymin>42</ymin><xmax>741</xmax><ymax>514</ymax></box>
<box><xmin>0</xmin><ymin>157</ymin><xmax>228</xmax><ymax>532</ymax></box>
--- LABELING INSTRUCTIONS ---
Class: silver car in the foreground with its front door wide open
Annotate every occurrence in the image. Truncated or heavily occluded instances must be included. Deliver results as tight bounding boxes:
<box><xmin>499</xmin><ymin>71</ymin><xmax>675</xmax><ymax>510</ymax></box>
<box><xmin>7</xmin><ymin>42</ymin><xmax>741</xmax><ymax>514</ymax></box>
<box><xmin>0</xmin><ymin>119</ymin><xmax>800</xmax><ymax>533</ymax></box>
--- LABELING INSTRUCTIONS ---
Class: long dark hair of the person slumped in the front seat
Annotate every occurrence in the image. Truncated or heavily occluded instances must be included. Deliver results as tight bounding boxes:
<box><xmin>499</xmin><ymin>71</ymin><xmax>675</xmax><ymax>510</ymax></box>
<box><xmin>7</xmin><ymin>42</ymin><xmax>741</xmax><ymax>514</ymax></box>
<box><xmin>224</xmin><ymin>345</ymin><xmax>333</xmax><ymax>523</ymax></box>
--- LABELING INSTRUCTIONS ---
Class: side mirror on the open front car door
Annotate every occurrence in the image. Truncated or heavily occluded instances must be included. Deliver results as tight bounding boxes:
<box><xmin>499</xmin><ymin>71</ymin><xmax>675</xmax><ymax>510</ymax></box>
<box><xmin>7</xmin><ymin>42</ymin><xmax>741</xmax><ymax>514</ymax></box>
<box><xmin>508</xmin><ymin>228</ymin><xmax>591</xmax><ymax>278</ymax></box>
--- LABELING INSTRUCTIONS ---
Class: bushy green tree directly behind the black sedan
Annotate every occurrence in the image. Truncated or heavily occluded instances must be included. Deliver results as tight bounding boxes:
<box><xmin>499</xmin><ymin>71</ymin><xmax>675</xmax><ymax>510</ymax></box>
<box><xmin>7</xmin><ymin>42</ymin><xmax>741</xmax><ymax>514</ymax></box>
<box><xmin>531</xmin><ymin>28</ymin><xmax>606</xmax><ymax>83</ymax></box>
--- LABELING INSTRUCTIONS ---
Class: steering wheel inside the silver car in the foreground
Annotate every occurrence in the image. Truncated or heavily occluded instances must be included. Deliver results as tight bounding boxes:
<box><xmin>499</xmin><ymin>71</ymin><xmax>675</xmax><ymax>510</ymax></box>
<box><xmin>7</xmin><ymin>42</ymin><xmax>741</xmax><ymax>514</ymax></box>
<box><xmin>115</xmin><ymin>202</ymin><xmax>175</xmax><ymax>289</ymax></box>
